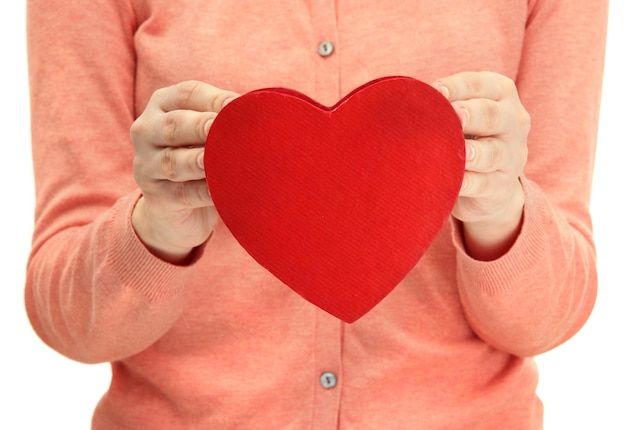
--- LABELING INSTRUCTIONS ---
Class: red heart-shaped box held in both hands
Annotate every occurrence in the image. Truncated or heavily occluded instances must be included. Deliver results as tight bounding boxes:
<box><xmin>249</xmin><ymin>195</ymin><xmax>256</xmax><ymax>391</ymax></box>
<box><xmin>204</xmin><ymin>77</ymin><xmax>465</xmax><ymax>322</ymax></box>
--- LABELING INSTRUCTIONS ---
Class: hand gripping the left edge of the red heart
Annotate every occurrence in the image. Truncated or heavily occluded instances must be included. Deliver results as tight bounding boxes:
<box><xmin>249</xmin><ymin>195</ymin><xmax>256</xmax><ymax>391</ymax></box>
<box><xmin>130</xmin><ymin>81</ymin><xmax>237</xmax><ymax>263</ymax></box>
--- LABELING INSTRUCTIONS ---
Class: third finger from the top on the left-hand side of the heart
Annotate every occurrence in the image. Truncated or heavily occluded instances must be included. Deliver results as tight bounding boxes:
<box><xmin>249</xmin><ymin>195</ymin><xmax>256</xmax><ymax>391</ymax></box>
<box><xmin>151</xmin><ymin>147</ymin><xmax>205</xmax><ymax>182</ymax></box>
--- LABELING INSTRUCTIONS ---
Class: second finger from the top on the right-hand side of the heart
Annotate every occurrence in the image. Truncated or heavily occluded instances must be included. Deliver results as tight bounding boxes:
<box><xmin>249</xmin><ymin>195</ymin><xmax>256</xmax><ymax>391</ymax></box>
<box><xmin>452</xmin><ymin>98</ymin><xmax>510</xmax><ymax>137</ymax></box>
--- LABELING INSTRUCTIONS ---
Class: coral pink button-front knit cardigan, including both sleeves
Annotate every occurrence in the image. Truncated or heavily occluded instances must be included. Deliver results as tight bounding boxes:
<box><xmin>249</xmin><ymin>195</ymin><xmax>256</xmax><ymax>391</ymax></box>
<box><xmin>25</xmin><ymin>0</ymin><xmax>607</xmax><ymax>430</ymax></box>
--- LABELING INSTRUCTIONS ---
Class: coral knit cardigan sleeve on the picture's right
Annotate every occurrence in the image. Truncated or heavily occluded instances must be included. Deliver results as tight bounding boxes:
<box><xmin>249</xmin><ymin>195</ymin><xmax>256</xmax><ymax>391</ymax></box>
<box><xmin>454</xmin><ymin>0</ymin><xmax>608</xmax><ymax>356</ymax></box>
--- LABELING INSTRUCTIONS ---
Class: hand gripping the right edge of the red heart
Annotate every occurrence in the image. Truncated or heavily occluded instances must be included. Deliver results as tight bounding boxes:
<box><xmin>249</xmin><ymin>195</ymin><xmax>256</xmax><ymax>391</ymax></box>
<box><xmin>433</xmin><ymin>72</ymin><xmax>530</xmax><ymax>260</ymax></box>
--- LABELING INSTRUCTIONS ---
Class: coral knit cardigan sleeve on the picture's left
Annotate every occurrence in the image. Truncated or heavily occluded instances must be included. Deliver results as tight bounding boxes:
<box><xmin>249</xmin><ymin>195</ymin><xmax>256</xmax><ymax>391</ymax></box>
<box><xmin>25</xmin><ymin>0</ymin><xmax>193</xmax><ymax>362</ymax></box>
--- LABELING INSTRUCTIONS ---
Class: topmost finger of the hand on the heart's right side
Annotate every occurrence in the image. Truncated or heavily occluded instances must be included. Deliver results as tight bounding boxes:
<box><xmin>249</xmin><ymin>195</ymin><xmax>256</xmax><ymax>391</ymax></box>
<box><xmin>433</xmin><ymin>72</ymin><xmax>512</xmax><ymax>102</ymax></box>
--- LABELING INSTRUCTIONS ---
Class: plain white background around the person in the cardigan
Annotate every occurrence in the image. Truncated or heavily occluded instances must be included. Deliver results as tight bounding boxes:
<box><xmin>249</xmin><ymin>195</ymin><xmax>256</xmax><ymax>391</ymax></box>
<box><xmin>0</xmin><ymin>0</ymin><xmax>626</xmax><ymax>430</ymax></box>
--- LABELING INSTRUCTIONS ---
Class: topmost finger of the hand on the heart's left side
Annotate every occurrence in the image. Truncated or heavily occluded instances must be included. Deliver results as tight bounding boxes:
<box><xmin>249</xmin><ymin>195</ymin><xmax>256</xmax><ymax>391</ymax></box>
<box><xmin>155</xmin><ymin>81</ymin><xmax>238</xmax><ymax>112</ymax></box>
